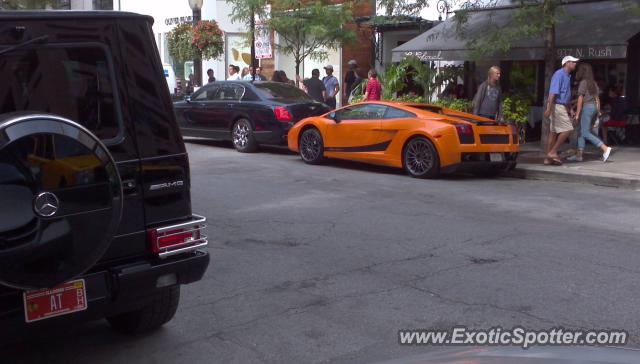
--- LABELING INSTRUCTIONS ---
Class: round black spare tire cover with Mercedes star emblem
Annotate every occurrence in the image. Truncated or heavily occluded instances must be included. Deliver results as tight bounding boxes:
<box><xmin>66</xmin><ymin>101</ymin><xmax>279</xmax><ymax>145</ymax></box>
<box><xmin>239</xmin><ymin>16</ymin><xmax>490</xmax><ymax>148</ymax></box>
<box><xmin>0</xmin><ymin>113</ymin><xmax>122</xmax><ymax>289</ymax></box>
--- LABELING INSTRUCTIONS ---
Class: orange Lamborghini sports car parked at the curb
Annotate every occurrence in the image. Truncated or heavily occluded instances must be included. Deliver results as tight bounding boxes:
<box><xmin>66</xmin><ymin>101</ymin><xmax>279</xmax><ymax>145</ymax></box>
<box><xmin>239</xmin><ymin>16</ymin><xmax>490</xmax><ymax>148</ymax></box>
<box><xmin>288</xmin><ymin>102</ymin><xmax>519</xmax><ymax>178</ymax></box>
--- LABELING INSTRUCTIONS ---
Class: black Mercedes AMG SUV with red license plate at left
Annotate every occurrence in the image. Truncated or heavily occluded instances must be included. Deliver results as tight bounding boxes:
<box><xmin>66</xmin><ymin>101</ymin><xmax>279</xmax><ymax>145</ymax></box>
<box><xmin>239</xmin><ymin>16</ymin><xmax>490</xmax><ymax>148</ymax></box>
<box><xmin>0</xmin><ymin>12</ymin><xmax>209</xmax><ymax>338</ymax></box>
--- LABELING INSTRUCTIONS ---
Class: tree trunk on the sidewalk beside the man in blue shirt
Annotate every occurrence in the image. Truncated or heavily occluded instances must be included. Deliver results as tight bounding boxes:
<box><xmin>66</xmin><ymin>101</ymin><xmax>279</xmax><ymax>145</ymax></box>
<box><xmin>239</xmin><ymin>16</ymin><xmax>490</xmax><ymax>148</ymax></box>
<box><xmin>540</xmin><ymin>0</ymin><xmax>556</xmax><ymax>154</ymax></box>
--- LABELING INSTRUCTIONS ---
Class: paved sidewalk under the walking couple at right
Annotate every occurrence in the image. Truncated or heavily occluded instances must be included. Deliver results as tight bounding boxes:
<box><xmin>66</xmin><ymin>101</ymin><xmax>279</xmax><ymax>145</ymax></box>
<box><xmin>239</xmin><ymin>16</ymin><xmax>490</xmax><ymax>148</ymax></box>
<box><xmin>509</xmin><ymin>142</ymin><xmax>640</xmax><ymax>191</ymax></box>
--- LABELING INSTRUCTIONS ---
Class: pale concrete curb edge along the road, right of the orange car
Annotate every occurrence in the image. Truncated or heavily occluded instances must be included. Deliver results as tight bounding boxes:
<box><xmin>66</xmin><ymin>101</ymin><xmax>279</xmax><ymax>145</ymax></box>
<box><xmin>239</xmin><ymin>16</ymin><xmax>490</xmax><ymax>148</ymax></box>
<box><xmin>506</xmin><ymin>164</ymin><xmax>640</xmax><ymax>191</ymax></box>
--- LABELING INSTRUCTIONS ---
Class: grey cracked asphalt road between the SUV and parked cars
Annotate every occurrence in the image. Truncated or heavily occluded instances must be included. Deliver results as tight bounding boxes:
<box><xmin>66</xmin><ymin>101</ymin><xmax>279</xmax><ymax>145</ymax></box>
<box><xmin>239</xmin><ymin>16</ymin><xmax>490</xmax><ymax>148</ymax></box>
<box><xmin>0</xmin><ymin>142</ymin><xmax>640</xmax><ymax>363</ymax></box>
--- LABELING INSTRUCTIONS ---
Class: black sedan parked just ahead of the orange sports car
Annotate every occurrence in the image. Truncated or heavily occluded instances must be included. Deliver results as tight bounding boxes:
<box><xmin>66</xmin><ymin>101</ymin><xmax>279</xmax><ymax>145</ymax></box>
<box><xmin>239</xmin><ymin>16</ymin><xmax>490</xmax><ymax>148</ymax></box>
<box><xmin>174</xmin><ymin>81</ymin><xmax>330</xmax><ymax>153</ymax></box>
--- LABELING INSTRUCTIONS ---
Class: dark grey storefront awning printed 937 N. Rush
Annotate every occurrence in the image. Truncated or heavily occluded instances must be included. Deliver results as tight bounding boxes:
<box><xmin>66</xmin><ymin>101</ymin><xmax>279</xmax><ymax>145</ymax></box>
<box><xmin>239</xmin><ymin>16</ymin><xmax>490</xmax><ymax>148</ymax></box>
<box><xmin>392</xmin><ymin>0</ymin><xmax>640</xmax><ymax>62</ymax></box>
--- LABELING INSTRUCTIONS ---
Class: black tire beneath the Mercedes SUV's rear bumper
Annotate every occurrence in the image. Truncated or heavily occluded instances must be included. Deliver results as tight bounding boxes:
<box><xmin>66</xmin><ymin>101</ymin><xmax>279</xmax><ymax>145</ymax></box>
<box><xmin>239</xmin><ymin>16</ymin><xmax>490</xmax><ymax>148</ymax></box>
<box><xmin>107</xmin><ymin>286</ymin><xmax>180</xmax><ymax>334</ymax></box>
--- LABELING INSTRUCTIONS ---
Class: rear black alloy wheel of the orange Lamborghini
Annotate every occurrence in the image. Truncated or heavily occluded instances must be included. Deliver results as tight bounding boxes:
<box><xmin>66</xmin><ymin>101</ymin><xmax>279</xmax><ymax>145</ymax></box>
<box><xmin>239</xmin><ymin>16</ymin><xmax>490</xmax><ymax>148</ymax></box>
<box><xmin>402</xmin><ymin>137</ymin><xmax>440</xmax><ymax>178</ymax></box>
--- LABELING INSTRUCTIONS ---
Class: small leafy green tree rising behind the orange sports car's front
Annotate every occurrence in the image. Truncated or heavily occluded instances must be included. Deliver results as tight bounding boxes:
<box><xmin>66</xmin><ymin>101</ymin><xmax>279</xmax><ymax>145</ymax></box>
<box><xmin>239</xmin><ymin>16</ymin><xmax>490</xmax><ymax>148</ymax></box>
<box><xmin>267</xmin><ymin>0</ymin><xmax>356</xmax><ymax>83</ymax></box>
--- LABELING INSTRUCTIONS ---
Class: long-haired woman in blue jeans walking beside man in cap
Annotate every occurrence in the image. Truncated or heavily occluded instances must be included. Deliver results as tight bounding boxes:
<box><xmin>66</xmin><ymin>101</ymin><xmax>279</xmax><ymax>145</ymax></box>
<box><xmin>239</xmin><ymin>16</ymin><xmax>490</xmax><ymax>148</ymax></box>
<box><xmin>567</xmin><ymin>63</ymin><xmax>611</xmax><ymax>162</ymax></box>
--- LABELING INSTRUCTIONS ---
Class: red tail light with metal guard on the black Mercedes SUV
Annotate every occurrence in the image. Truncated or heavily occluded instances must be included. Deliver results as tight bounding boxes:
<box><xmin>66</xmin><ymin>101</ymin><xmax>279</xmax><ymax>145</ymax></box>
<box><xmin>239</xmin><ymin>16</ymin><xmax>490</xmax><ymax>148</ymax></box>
<box><xmin>147</xmin><ymin>215</ymin><xmax>208</xmax><ymax>258</ymax></box>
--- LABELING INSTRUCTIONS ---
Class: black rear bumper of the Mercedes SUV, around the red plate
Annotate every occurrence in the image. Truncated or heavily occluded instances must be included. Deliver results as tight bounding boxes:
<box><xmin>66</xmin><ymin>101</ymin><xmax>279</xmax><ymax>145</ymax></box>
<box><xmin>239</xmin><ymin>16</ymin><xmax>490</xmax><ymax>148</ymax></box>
<box><xmin>0</xmin><ymin>251</ymin><xmax>209</xmax><ymax>340</ymax></box>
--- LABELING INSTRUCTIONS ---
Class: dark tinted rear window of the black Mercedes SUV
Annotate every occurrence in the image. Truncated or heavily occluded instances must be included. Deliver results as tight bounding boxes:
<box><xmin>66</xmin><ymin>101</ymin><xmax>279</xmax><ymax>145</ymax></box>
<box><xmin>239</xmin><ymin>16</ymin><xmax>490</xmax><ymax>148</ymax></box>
<box><xmin>0</xmin><ymin>46</ymin><xmax>121</xmax><ymax>142</ymax></box>
